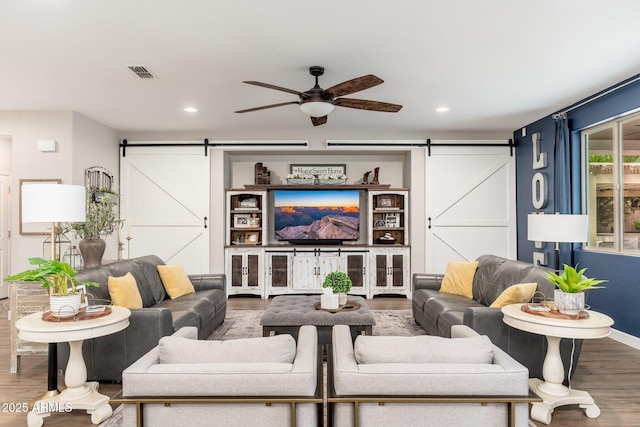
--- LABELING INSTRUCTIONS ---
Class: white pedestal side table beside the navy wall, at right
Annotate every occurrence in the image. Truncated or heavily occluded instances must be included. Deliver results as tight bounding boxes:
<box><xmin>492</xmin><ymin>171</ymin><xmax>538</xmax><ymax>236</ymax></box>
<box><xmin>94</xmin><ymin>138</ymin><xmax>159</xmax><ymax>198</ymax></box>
<box><xmin>502</xmin><ymin>304</ymin><xmax>613</xmax><ymax>424</ymax></box>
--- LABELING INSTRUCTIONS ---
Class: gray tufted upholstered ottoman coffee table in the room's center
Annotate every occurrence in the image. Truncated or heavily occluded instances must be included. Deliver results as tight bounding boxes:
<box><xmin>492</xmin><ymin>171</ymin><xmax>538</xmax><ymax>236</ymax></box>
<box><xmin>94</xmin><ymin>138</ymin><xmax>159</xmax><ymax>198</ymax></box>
<box><xmin>260</xmin><ymin>295</ymin><xmax>376</xmax><ymax>344</ymax></box>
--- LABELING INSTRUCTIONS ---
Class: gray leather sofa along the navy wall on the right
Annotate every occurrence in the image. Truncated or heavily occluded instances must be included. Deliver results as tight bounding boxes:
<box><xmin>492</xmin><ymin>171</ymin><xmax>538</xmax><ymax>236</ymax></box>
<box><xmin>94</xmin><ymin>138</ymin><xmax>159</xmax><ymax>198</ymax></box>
<box><xmin>412</xmin><ymin>255</ymin><xmax>582</xmax><ymax>378</ymax></box>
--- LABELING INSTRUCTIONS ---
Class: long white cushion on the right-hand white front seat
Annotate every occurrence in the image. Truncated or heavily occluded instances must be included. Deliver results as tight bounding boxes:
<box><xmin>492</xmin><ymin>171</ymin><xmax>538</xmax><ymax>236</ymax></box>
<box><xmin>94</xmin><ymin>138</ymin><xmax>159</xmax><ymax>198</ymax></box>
<box><xmin>354</xmin><ymin>335</ymin><xmax>493</xmax><ymax>364</ymax></box>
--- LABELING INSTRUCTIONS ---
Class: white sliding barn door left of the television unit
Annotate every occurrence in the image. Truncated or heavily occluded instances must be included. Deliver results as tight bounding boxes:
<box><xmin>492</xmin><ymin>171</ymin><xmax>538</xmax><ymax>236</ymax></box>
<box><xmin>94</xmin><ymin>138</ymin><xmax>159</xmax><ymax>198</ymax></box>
<box><xmin>120</xmin><ymin>147</ymin><xmax>211</xmax><ymax>274</ymax></box>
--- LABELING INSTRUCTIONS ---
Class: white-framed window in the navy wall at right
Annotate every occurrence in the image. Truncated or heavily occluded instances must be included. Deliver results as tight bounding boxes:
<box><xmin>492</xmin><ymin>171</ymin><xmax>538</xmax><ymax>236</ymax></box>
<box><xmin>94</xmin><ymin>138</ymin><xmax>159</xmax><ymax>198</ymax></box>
<box><xmin>582</xmin><ymin>114</ymin><xmax>640</xmax><ymax>253</ymax></box>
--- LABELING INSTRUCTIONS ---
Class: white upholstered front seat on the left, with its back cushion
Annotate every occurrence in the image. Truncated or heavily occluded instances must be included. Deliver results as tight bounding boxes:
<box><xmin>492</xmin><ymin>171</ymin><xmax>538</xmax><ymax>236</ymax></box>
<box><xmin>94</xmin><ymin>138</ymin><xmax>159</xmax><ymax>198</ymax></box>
<box><xmin>116</xmin><ymin>326</ymin><xmax>322</xmax><ymax>427</ymax></box>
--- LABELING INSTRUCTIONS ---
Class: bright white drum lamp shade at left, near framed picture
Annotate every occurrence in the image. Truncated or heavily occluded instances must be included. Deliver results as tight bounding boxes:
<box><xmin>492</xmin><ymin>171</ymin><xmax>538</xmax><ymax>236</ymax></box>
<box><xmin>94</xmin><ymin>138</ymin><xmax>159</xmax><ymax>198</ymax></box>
<box><xmin>22</xmin><ymin>184</ymin><xmax>86</xmax><ymax>222</ymax></box>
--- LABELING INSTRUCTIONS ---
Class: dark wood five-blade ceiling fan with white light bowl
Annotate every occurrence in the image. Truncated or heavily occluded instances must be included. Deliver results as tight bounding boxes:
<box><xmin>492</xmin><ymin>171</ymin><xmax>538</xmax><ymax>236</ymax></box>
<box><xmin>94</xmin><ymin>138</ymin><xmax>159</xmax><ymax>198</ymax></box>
<box><xmin>235</xmin><ymin>65</ymin><xmax>402</xmax><ymax>126</ymax></box>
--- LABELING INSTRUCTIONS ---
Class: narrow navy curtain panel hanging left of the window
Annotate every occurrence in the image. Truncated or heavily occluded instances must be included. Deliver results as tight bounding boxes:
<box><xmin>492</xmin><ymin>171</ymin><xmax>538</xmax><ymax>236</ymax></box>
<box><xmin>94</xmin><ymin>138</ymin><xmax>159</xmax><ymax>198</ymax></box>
<box><xmin>553</xmin><ymin>113</ymin><xmax>574</xmax><ymax>270</ymax></box>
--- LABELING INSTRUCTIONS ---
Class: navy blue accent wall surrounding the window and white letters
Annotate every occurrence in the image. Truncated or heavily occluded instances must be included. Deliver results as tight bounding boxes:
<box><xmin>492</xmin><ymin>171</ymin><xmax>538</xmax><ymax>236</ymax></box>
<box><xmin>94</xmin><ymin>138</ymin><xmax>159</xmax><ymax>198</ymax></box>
<box><xmin>514</xmin><ymin>76</ymin><xmax>640</xmax><ymax>337</ymax></box>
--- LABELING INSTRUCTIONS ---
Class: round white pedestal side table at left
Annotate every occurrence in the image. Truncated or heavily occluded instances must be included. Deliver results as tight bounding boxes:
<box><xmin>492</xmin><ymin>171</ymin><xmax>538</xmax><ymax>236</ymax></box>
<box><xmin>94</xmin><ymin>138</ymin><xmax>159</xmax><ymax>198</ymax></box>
<box><xmin>16</xmin><ymin>306</ymin><xmax>131</xmax><ymax>427</ymax></box>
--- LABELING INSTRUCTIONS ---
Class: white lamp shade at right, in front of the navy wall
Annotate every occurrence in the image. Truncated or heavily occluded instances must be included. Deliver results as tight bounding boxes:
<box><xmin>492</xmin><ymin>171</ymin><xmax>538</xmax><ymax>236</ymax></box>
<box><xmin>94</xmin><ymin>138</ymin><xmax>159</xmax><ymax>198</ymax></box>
<box><xmin>527</xmin><ymin>214</ymin><xmax>589</xmax><ymax>243</ymax></box>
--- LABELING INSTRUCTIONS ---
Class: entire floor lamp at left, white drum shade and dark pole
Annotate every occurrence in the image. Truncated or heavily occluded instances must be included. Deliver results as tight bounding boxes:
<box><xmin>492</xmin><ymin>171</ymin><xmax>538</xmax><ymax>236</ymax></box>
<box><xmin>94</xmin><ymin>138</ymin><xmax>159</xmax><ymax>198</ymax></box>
<box><xmin>22</xmin><ymin>184</ymin><xmax>86</xmax><ymax>396</ymax></box>
